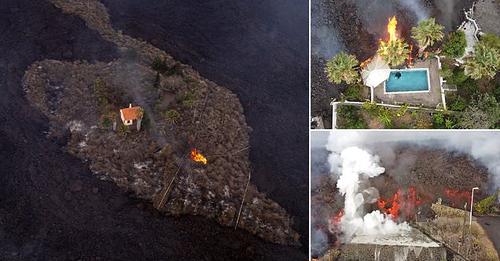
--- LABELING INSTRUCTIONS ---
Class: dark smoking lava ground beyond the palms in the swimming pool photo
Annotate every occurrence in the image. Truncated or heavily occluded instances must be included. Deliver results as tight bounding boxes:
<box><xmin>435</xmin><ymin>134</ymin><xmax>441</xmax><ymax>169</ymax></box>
<box><xmin>311</xmin><ymin>0</ymin><xmax>473</xmax><ymax>123</ymax></box>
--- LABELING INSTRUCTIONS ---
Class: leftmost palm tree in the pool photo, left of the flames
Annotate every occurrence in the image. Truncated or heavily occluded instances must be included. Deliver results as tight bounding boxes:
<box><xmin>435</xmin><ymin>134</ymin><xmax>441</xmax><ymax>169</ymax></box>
<box><xmin>325</xmin><ymin>52</ymin><xmax>359</xmax><ymax>84</ymax></box>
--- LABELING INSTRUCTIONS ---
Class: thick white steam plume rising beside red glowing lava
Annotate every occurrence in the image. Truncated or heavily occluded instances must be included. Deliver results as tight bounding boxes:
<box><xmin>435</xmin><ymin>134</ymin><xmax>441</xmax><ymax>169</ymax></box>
<box><xmin>330</xmin><ymin>147</ymin><xmax>410</xmax><ymax>241</ymax></box>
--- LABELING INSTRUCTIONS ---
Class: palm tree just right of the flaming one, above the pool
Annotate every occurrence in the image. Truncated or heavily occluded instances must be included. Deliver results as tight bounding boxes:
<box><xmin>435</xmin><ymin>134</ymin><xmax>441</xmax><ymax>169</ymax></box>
<box><xmin>411</xmin><ymin>18</ymin><xmax>444</xmax><ymax>54</ymax></box>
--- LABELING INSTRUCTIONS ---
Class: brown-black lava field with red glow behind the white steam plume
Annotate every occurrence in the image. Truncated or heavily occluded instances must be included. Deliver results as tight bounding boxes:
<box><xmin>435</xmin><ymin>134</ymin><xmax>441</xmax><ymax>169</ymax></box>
<box><xmin>311</xmin><ymin>134</ymin><xmax>494</xmax><ymax>256</ymax></box>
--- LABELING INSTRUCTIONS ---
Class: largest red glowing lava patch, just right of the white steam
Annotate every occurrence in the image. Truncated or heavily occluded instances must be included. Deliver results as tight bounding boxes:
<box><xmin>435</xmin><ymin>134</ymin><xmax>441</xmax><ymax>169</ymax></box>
<box><xmin>377</xmin><ymin>187</ymin><xmax>422</xmax><ymax>220</ymax></box>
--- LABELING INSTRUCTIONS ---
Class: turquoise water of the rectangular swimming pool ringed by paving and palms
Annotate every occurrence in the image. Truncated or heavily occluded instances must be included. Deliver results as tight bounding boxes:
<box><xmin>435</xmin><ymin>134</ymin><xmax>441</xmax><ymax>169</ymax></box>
<box><xmin>385</xmin><ymin>70</ymin><xmax>429</xmax><ymax>93</ymax></box>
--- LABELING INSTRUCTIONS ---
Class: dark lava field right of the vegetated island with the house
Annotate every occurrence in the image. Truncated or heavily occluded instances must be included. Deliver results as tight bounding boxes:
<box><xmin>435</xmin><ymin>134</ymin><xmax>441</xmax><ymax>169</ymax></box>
<box><xmin>97</xmin><ymin>0</ymin><xmax>308</xmax><ymax>252</ymax></box>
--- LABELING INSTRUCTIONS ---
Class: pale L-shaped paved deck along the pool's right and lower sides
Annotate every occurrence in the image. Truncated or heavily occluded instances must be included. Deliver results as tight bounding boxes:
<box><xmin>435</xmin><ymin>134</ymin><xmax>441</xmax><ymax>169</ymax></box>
<box><xmin>374</xmin><ymin>58</ymin><xmax>443</xmax><ymax>108</ymax></box>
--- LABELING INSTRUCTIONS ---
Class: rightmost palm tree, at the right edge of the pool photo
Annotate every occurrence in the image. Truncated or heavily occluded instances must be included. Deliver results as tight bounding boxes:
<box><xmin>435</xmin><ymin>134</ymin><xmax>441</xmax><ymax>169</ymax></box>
<box><xmin>465</xmin><ymin>43</ymin><xmax>500</xmax><ymax>80</ymax></box>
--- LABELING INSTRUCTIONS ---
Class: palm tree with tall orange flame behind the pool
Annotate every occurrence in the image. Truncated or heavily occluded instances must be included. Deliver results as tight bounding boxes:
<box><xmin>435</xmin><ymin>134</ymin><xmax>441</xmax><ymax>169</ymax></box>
<box><xmin>377</xmin><ymin>16</ymin><xmax>410</xmax><ymax>66</ymax></box>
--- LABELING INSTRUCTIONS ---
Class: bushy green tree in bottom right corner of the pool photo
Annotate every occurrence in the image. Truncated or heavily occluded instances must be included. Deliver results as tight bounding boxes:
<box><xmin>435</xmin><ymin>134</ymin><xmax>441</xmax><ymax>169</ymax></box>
<box><xmin>458</xmin><ymin>93</ymin><xmax>500</xmax><ymax>129</ymax></box>
